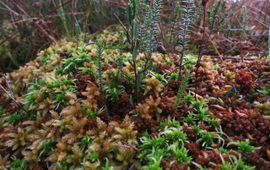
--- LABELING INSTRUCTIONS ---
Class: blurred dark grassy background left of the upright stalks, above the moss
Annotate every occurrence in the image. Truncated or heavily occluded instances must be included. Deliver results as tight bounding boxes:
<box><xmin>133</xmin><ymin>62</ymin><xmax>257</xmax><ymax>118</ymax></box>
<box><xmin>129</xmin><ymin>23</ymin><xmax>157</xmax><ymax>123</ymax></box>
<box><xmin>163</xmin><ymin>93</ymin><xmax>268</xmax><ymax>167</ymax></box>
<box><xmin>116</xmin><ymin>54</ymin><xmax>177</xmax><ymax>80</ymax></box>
<box><xmin>0</xmin><ymin>0</ymin><xmax>124</xmax><ymax>72</ymax></box>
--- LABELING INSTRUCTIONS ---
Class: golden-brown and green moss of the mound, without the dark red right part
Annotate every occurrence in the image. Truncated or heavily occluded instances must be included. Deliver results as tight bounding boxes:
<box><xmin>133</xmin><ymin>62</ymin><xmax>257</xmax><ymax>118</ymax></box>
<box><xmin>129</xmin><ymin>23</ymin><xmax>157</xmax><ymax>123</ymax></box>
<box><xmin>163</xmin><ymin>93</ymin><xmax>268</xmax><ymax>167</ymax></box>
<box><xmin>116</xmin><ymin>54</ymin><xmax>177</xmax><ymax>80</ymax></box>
<box><xmin>0</xmin><ymin>25</ymin><xmax>262</xmax><ymax>170</ymax></box>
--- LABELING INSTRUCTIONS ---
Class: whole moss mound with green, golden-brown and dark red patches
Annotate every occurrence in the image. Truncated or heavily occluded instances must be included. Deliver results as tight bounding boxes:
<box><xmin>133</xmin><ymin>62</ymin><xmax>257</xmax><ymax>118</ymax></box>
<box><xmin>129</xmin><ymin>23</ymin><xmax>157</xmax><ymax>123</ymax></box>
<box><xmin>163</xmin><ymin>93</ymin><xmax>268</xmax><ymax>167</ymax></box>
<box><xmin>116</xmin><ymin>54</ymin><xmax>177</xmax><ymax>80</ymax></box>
<box><xmin>0</xmin><ymin>26</ymin><xmax>270</xmax><ymax>170</ymax></box>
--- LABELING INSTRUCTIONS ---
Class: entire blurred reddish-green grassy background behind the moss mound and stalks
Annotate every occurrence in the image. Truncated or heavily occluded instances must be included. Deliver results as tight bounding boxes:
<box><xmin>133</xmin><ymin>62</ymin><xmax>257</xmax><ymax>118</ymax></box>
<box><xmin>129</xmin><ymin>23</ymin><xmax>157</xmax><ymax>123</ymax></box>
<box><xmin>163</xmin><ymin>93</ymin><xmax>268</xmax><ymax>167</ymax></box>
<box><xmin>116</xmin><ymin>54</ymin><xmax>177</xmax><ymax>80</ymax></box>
<box><xmin>0</xmin><ymin>0</ymin><xmax>270</xmax><ymax>72</ymax></box>
